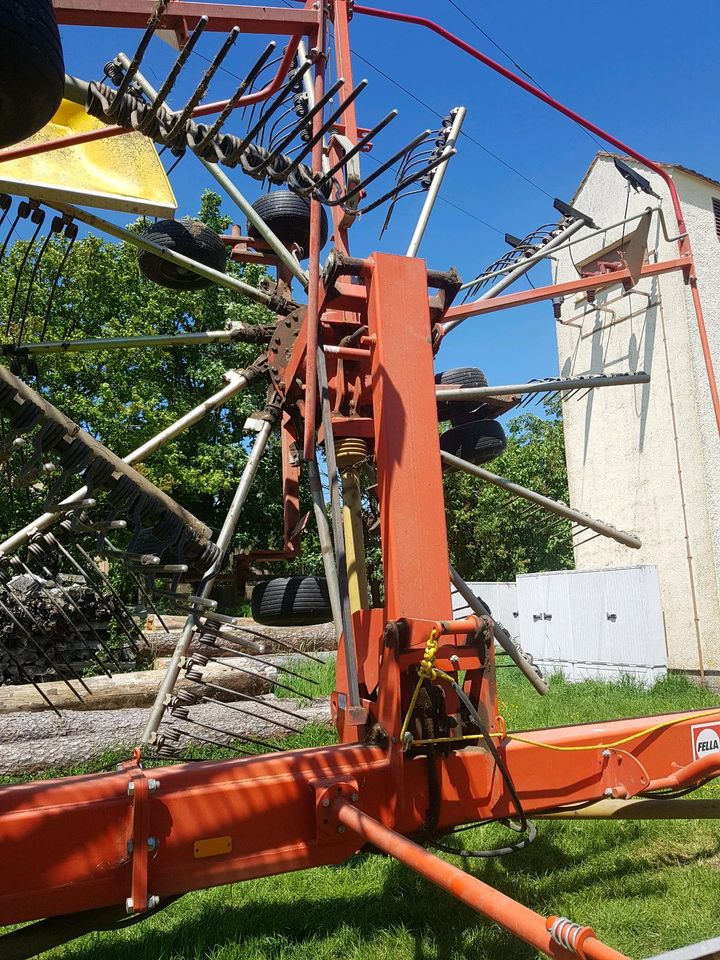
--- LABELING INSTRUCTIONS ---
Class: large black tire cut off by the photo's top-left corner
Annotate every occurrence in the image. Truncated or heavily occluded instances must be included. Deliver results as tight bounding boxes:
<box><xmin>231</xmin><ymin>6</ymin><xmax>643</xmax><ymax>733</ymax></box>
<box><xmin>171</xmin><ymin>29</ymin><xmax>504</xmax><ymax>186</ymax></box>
<box><xmin>0</xmin><ymin>0</ymin><xmax>65</xmax><ymax>148</ymax></box>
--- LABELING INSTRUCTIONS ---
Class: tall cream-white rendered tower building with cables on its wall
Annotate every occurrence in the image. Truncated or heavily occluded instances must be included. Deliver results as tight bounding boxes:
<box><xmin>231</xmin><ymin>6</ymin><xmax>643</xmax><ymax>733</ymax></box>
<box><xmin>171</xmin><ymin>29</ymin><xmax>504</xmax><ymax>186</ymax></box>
<box><xmin>553</xmin><ymin>153</ymin><xmax>720</xmax><ymax>685</ymax></box>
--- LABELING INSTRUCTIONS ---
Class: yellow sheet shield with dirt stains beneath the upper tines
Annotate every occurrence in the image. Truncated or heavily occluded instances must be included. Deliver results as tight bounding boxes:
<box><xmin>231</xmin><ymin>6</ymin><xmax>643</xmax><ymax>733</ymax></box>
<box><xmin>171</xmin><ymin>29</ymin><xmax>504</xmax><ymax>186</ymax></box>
<box><xmin>0</xmin><ymin>100</ymin><xmax>177</xmax><ymax>217</ymax></box>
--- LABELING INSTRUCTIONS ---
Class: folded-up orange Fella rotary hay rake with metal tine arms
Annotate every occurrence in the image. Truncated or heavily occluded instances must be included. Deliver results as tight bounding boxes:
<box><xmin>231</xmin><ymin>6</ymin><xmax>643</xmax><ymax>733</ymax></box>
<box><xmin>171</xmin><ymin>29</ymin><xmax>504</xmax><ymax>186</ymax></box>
<box><xmin>0</xmin><ymin>0</ymin><xmax>720</xmax><ymax>960</ymax></box>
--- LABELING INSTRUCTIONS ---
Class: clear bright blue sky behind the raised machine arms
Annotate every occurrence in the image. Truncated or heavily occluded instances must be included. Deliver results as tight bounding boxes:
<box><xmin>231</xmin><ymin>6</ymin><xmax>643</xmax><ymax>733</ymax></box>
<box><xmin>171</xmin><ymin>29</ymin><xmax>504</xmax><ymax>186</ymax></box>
<box><xmin>57</xmin><ymin>0</ymin><xmax>720</xmax><ymax>383</ymax></box>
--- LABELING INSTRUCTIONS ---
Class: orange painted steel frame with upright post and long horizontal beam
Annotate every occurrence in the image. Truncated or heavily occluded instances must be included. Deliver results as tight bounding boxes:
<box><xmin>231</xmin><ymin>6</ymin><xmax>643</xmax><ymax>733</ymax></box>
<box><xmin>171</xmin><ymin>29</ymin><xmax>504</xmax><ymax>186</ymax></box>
<box><xmin>0</xmin><ymin>0</ymin><xmax>720</xmax><ymax>960</ymax></box>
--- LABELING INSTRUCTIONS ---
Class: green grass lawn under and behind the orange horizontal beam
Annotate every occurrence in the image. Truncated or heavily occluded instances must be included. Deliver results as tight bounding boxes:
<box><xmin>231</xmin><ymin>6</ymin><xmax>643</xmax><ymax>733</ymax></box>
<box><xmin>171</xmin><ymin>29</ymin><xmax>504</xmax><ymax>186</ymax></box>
<box><xmin>0</xmin><ymin>667</ymin><xmax>720</xmax><ymax>960</ymax></box>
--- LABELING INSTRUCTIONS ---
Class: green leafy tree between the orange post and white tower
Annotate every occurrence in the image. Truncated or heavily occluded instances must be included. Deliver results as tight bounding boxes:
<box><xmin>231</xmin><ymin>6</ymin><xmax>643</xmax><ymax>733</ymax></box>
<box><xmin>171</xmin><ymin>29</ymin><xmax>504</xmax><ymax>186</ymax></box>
<box><xmin>444</xmin><ymin>400</ymin><xmax>574</xmax><ymax>580</ymax></box>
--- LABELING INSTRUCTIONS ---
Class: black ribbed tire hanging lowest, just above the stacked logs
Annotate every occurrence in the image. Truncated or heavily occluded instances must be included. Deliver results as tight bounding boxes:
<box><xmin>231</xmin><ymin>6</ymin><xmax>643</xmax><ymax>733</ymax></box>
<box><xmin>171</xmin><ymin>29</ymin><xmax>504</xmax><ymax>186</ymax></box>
<box><xmin>251</xmin><ymin>576</ymin><xmax>332</xmax><ymax>627</ymax></box>
